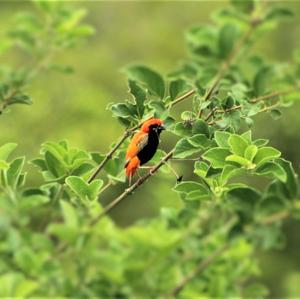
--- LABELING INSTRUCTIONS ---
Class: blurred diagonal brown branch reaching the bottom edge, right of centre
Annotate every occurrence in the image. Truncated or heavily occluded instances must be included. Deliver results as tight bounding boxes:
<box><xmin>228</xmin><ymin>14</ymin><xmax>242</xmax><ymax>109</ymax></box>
<box><xmin>166</xmin><ymin>244</ymin><xmax>229</xmax><ymax>298</ymax></box>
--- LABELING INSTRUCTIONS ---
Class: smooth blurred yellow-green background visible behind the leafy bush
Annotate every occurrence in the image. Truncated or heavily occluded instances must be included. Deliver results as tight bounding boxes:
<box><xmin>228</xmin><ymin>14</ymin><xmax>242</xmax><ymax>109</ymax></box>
<box><xmin>0</xmin><ymin>0</ymin><xmax>300</xmax><ymax>298</ymax></box>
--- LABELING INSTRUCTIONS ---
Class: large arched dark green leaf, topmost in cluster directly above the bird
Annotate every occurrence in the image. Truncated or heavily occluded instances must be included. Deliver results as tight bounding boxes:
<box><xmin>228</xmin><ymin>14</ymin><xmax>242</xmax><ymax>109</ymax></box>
<box><xmin>124</xmin><ymin>65</ymin><xmax>165</xmax><ymax>99</ymax></box>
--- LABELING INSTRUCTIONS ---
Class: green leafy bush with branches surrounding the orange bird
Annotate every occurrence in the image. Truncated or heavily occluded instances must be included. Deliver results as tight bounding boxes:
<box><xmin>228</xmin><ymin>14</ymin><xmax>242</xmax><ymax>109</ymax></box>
<box><xmin>0</xmin><ymin>0</ymin><xmax>300</xmax><ymax>298</ymax></box>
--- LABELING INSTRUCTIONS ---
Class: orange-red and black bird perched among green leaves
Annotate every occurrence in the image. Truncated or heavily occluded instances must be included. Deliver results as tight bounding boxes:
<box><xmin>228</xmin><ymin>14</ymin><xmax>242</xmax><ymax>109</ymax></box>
<box><xmin>125</xmin><ymin>118</ymin><xmax>165</xmax><ymax>185</ymax></box>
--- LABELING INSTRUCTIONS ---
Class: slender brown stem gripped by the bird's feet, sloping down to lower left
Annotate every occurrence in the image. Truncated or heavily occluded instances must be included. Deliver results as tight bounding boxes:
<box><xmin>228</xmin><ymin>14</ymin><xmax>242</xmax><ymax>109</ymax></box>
<box><xmin>90</xmin><ymin>149</ymin><xmax>174</xmax><ymax>226</ymax></box>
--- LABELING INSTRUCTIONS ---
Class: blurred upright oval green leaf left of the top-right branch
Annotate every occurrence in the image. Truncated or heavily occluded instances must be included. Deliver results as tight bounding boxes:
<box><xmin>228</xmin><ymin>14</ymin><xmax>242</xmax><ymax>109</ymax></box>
<box><xmin>218</xmin><ymin>24</ymin><xmax>237</xmax><ymax>58</ymax></box>
